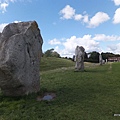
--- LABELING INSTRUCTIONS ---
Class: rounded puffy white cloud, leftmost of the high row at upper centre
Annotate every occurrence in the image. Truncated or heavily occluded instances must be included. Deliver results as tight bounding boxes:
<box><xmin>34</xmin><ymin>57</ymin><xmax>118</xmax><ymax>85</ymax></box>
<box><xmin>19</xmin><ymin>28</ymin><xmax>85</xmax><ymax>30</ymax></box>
<box><xmin>60</xmin><ymin>5</ymin><xmax>75</xmax><ymax>19</ymax></box>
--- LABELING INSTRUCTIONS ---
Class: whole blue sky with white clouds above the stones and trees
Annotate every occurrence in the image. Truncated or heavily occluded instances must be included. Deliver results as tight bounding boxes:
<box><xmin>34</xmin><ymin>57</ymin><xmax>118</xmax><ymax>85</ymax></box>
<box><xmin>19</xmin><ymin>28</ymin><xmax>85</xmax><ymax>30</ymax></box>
<box><xmin>0</xmin><ymin>0</ymin><xmax>120</xmax><ymax>57</ymax></box>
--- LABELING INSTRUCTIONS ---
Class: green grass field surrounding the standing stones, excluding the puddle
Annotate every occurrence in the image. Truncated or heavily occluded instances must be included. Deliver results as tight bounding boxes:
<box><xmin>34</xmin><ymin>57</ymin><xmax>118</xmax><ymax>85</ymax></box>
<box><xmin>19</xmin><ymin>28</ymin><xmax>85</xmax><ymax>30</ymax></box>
<box><xmin>0</xmin><ymin>58</ymin><xmax>120</xmax><ymax>120</ymax></box>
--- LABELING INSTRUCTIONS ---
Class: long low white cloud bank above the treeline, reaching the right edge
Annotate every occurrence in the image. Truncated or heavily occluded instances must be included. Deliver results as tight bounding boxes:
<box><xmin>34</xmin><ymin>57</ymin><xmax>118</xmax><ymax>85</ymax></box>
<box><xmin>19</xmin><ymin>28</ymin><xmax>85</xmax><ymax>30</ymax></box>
<box><xmin>49</xmin><ymin>34</ymin><xmax>120</xmax><ymax>57</ymax></box>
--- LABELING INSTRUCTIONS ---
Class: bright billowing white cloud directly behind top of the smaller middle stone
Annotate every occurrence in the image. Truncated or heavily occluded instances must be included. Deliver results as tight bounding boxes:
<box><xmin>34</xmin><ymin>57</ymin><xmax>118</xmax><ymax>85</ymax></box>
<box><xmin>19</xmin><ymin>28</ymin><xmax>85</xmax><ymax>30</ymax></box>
<box><xmin>51</xmin><ymin>35</ymin><xmax>101</xmax><ymax>57</ymax></box>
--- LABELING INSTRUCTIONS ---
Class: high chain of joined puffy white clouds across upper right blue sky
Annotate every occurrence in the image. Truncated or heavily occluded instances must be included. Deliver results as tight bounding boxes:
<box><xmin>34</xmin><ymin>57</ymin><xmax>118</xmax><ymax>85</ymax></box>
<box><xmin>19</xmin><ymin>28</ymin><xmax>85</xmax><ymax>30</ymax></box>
<box><xmin>60</xmin><ymin>5</ymin><xmax>110</xmax><ymax>28</ymax></box>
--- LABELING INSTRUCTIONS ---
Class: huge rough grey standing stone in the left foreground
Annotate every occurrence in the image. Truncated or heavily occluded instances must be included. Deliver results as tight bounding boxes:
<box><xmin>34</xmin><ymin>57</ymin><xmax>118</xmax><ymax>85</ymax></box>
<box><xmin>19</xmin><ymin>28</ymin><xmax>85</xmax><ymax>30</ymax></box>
<box><xmin>0</xmin><ymin>21</ymin><xmax>43</xmax><ymax>96</ymax></box>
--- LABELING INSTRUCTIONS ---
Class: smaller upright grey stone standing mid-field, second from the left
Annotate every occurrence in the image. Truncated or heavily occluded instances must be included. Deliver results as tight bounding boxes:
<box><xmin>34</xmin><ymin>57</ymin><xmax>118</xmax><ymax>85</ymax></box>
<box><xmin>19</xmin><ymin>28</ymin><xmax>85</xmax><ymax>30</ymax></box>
<box><xmin>75</xmin><ymin>46</ymin><xmax>85</xmax><ymax>71</ymax></box>
